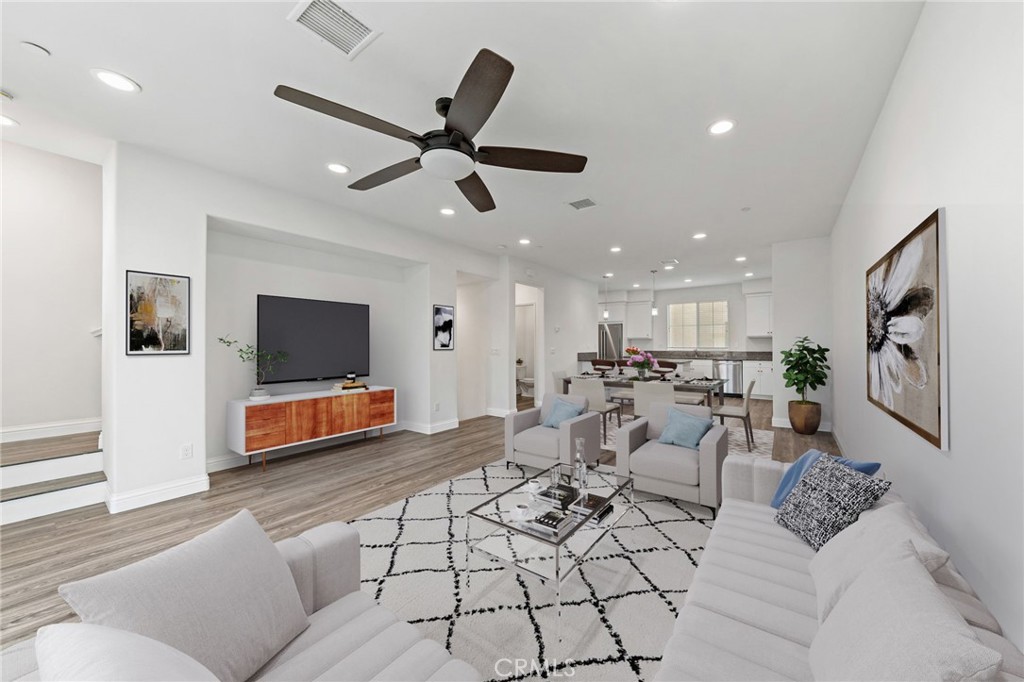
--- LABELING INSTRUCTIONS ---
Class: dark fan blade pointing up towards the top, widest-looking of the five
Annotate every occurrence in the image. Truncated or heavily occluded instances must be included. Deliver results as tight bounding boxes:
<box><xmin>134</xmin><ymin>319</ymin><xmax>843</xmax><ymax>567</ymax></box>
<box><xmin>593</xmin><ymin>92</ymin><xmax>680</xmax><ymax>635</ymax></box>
<box><xmin>444</xmin><ymin>49</ymin><xmax>515</xmax><ymax>139</ymax></box>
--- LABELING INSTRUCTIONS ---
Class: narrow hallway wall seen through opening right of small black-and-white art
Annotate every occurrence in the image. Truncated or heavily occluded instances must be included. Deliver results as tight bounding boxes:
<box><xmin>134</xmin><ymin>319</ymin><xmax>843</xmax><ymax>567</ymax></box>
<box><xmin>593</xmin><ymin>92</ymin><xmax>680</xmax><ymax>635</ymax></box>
<box><xmin>455</xmin><ymin>282</ymin><xmax>498</xmax><ymax>421</ymax></box>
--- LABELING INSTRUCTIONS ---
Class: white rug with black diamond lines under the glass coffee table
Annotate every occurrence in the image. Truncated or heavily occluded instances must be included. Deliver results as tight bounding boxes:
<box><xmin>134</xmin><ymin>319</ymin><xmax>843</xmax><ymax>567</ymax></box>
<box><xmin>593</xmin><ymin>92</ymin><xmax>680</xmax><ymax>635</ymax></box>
<box><xmin>352</xmin><ymin>458</ymin><xmax>712</xmax><ymax>681</ymax></box>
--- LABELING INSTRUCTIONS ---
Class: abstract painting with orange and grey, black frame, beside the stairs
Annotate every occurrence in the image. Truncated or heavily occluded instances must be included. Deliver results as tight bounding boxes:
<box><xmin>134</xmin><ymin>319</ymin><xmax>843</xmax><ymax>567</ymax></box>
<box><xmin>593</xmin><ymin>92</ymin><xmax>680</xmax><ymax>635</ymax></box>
<box><xmin>125</xmin><ymin>270</ymin><xmax>191</xmax><ymax>355</ymax></box>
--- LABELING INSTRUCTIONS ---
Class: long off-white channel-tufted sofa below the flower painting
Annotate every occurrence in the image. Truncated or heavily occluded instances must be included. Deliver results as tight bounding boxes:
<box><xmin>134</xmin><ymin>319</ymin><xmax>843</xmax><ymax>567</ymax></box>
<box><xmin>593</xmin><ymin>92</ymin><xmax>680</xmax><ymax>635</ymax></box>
<box><xmin>655</xmin><ymin>455</ymin><xmax>1024</xmax><ymax>682</ymax></box>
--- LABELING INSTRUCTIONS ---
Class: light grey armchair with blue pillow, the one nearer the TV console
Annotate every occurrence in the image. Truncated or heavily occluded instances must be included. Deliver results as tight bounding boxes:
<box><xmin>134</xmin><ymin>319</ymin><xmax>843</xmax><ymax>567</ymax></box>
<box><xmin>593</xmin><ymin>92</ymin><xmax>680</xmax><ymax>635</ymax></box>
<box><xmin>505</xmin><ymin>393</ymin><xmax>601</xmax><ymax>469</ymax></box>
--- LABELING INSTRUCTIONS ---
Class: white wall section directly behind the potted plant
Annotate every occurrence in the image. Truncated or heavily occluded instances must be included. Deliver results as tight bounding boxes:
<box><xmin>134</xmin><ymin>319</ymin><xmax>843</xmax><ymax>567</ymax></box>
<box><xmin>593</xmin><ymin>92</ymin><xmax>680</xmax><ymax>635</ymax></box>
<box><xmin>771</xmin><ymin>237</ymin><xmax>835</xmax><ymax>431</ymax></box>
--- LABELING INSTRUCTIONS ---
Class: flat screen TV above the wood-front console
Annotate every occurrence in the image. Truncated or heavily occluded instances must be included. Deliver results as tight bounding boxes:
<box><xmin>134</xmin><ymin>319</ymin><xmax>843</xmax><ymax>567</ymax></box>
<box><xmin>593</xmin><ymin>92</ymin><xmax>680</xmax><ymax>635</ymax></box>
<box><xmin>256</xmin><ymin>294</ymin><xmax>370</xmax><ymax>384</ymax></box>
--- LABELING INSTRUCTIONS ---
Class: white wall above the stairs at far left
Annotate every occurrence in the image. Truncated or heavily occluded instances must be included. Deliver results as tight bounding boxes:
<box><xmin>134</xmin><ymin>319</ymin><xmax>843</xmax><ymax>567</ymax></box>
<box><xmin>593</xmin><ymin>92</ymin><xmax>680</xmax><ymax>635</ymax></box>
<box><xmin>0</xmin><ymin>142</ymin><xmax>101</xmax><ymax>432</ymax></box>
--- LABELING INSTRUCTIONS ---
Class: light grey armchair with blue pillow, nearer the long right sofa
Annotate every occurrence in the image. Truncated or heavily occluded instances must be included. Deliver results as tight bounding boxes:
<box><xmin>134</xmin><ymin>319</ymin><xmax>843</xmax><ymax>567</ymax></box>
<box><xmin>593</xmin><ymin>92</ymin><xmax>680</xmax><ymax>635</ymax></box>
<box><xmin>615</xmin><ymin>402</ymin><xmax>729</xmax><ymax>513</ymax></box>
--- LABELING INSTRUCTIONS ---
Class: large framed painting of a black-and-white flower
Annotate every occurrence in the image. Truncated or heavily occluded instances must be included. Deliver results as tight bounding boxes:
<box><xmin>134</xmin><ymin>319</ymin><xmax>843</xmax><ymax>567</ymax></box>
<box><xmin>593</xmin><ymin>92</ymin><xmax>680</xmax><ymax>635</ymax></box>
<box><xmin>866</xmin><ymin>209</ymin><xmax>949</xmax><ymax>450</ymax></box>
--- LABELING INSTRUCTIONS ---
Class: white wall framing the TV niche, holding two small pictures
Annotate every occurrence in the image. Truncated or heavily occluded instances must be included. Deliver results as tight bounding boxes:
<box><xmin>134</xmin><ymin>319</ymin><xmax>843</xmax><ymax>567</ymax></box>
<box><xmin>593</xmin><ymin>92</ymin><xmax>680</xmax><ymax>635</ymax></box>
<box><xmin>102</xmin><ymin>143</ymin><xmax>501</xmax><ymax>511</ymax></box>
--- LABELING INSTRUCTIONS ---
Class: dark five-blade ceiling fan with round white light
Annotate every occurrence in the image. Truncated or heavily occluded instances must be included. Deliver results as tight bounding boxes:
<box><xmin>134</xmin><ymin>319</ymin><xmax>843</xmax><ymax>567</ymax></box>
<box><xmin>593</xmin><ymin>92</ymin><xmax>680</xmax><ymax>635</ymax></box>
<box><xmin>273</xmin><ymin>49</ymin><xmax>587</xmax><ymax>212</ymax></box>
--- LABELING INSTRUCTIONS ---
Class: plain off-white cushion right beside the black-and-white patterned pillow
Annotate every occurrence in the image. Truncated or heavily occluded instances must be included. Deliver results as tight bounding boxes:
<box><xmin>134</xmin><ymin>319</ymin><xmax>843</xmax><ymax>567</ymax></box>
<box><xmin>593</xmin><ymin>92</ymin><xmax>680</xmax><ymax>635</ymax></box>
<box><xmin>808</xmin><ymin>503</ymin><xmax>949</xmax><ymax>623</ymax></box>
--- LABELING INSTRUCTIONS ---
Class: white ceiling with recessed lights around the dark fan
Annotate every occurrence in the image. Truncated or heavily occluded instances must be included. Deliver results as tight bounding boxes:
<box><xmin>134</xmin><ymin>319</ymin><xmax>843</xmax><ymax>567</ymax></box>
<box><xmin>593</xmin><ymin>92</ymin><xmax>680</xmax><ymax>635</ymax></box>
<box><xmin>0</xmin><ymin>0</ymin><xmax>921</xmax><ymax>289</ymax></box>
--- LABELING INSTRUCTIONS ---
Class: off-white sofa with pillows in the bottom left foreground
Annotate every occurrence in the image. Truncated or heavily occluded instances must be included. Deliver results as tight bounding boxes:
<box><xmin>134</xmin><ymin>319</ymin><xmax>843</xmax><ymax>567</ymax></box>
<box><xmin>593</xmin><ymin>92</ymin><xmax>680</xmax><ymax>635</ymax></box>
<box><xmin>0</xmin><ymin>511</ymin><xmax>480</xmax><ymax>682</ymax></box>
